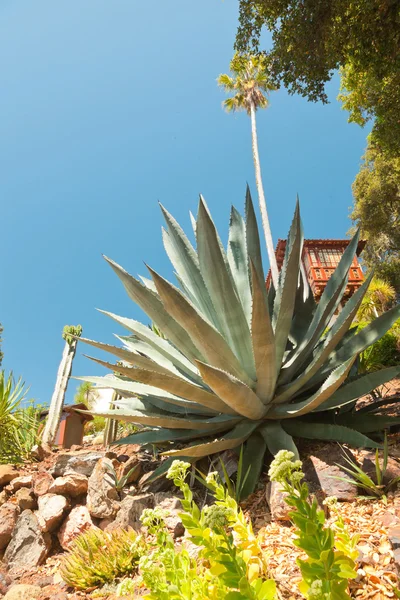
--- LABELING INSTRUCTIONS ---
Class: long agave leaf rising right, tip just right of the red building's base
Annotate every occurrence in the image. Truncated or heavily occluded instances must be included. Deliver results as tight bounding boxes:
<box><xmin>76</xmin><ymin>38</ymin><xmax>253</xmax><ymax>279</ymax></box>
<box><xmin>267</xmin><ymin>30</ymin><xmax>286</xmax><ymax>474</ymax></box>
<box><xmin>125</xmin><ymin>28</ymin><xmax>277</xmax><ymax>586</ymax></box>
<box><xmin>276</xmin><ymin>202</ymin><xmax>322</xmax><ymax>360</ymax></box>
<box><xmin>274</xmin><ymin>273</ymin><xmax>373</xmax><ymax>404</ymax></box>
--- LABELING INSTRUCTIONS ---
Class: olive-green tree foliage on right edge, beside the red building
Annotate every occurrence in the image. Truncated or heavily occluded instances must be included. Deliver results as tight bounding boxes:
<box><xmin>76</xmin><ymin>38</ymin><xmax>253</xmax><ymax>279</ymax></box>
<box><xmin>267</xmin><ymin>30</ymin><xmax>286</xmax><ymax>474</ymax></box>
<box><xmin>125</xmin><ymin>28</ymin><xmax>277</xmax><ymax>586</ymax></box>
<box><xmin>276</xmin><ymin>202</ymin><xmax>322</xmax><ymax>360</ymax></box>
<box><xmin>351</xmin><ymin>141</ymin><xmax>400</xmax><ymax>293</ymax></box>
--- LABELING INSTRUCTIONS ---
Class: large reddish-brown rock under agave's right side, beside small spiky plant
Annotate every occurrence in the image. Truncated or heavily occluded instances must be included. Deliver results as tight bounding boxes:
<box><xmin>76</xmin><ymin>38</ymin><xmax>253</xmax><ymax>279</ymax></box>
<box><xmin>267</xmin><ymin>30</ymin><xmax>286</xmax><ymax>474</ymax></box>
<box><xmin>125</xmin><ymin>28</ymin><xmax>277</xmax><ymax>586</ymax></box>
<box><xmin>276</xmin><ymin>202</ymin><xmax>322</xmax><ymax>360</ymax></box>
<box><xmin>303</xmin><ymin>444</ymin><xmax>357</xmax><ymax>502</ymax></box>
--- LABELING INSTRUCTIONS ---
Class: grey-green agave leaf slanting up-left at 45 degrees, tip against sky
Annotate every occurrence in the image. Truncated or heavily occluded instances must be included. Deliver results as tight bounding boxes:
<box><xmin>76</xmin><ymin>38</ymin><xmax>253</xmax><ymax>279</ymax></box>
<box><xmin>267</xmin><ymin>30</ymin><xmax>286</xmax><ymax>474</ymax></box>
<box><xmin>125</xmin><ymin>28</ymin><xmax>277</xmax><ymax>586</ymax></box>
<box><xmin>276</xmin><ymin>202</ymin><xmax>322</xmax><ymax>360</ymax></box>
<box><xmin>104</xmin><ymin>257</ymin><xmax>202</xmax><ymax>360</ymax></box>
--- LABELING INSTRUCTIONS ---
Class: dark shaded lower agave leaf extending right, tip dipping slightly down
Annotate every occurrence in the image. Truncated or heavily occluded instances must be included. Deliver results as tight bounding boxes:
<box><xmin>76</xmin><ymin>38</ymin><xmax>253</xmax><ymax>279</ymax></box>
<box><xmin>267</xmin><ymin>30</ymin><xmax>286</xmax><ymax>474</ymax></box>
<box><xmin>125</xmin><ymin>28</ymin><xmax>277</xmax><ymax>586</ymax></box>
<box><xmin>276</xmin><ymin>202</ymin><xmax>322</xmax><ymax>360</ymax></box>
<box><xmin>282</xmin><ymin>419</ymin><xmax>380</xmax><ymax>448</ymax></box>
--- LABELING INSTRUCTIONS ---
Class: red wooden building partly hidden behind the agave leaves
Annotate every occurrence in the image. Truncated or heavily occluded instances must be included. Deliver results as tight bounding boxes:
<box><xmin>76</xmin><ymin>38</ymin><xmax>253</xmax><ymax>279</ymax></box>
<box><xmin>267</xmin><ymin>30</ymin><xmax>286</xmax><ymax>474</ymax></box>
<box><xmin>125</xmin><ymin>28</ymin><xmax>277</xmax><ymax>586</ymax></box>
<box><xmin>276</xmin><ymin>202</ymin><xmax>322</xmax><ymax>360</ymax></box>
<box><xmin>267</xmin><ymin>240</ymin><xmax>366</xmax><ymax>301</ymax></box>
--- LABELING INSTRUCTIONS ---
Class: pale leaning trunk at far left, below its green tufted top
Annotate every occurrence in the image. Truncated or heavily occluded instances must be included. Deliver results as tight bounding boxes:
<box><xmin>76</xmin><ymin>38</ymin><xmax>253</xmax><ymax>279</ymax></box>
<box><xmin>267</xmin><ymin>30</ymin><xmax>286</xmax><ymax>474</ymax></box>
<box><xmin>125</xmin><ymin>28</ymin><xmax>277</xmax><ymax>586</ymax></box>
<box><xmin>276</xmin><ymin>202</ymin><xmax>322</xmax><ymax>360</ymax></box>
<box><xmin>43</xmin><ymin>340</ymin><xmax>77</xmax><ymax>444</ymax></box>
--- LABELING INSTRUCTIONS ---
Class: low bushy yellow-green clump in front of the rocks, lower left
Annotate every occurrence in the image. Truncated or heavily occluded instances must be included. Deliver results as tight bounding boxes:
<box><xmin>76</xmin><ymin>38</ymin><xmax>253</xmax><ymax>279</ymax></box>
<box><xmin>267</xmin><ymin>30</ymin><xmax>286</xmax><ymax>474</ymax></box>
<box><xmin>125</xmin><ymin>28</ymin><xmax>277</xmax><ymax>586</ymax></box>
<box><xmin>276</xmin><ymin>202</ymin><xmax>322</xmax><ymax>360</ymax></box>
<box><xmin>60</xmin><ymin>529</ymin><xmax>146</xmax><ymax>590</ymax></box>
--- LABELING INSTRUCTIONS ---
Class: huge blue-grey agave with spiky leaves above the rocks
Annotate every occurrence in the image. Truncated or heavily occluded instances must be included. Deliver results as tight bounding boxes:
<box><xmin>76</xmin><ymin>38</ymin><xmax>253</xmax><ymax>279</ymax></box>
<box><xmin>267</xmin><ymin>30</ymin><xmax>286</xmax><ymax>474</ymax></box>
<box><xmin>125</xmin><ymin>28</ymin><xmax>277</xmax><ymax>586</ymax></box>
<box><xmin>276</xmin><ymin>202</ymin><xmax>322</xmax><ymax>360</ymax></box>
<box><xmin>80</xmin><ymin>191</ymin><xmax>400</xmax><ymax>493</ymax></box>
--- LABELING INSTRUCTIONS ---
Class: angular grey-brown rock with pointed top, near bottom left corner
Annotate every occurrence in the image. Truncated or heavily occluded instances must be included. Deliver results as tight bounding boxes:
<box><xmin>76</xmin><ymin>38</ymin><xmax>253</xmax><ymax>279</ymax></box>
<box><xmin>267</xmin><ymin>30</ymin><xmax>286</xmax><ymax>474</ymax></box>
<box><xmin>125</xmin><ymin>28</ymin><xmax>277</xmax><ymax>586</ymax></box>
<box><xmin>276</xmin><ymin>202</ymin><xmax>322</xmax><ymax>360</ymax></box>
<box><xmin>4</xmin><ymin>510</ymin><xmax>51</xmax><ymax>570</ymax></box>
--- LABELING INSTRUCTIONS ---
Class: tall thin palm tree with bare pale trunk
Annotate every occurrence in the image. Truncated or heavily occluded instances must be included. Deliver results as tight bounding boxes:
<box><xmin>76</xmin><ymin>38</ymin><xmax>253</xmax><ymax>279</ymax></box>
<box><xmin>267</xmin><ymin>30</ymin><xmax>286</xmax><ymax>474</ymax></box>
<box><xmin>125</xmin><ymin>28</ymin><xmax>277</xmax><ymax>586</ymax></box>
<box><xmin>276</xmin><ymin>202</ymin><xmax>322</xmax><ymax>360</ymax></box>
<box><xmin>217</xmin><ymin>53</ymin><xmax>278</xmax><ymax>289</ymax></box>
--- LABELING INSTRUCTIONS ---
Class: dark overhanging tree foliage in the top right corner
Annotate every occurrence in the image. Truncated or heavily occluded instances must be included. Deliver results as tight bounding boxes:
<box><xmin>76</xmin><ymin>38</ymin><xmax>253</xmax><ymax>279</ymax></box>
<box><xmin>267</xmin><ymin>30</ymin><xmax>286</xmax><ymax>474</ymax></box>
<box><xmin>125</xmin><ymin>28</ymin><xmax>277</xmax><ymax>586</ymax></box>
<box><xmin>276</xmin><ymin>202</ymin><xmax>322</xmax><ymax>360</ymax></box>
<box><xmin>235</xmin><ymin>0</ymin><xmax>400</xmax><ymax>151</ymax></box>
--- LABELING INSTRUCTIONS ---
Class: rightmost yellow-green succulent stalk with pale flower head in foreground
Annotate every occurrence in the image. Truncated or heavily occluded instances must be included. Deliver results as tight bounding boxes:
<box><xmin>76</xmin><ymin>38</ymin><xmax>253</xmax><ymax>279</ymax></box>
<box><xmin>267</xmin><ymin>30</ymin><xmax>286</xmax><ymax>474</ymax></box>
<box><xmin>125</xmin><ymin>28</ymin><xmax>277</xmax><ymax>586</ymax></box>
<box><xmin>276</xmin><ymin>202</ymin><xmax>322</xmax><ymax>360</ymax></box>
<box><xmin>268</xmin><ymin>450</ymin><xmax>358</xmax><ymax>600</ymax></box>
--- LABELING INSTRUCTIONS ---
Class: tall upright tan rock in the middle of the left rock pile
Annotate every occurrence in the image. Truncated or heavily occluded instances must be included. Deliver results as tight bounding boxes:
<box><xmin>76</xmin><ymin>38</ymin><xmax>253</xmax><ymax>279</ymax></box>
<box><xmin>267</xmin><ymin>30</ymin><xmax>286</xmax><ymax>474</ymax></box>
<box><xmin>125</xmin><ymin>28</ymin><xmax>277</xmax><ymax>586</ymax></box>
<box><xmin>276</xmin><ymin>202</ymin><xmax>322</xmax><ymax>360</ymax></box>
<box><xmin>87</xmin><ymin>458</ymin><xmax>120</xmax><ymax>519</ymax></box>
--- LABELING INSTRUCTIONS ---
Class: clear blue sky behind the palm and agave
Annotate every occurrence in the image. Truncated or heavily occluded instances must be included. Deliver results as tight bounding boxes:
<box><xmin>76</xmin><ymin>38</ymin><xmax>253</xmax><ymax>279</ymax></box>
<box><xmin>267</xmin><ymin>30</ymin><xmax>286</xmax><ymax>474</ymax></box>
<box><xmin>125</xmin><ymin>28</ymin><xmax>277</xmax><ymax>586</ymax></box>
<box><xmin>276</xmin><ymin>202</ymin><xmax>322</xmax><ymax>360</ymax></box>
<box><xmin>0</xmin><ymin>0</ymin><xmax>367</xmax><ymax>402</ymax></box>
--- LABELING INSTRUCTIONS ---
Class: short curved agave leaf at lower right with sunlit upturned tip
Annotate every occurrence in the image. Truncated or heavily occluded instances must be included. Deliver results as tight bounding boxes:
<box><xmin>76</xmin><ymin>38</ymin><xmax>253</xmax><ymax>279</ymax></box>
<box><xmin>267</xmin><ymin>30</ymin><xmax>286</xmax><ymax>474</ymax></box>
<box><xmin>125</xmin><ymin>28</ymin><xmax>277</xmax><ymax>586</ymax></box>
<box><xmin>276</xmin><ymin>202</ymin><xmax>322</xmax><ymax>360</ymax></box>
<box><xmin>268</xmin><ymin>357</ymin><xmax>355</xmax><ymax>419</ymax></box>
